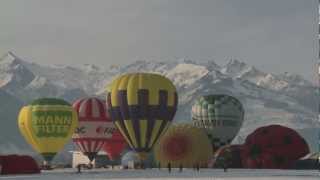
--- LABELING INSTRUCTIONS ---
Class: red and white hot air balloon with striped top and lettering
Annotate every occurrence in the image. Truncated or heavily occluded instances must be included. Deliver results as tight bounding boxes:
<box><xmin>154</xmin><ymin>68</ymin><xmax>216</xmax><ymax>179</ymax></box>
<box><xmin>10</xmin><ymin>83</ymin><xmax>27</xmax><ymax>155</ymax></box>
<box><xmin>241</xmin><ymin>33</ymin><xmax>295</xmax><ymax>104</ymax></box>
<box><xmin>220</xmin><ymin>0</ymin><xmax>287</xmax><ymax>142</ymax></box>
<box><xmin>72</xmin><ymin>97</ymin><xmax>116</xmax><ymax>161</ymax></box>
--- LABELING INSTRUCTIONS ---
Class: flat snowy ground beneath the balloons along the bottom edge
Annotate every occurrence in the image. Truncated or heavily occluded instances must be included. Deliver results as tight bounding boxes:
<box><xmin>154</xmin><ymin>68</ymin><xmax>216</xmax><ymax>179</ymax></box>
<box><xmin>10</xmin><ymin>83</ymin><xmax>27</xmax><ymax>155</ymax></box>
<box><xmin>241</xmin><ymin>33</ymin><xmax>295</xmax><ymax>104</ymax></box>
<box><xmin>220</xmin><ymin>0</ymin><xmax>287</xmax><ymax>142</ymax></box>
<box><xmin>0</xmin><ymin>169</ymin><xmax>320</xmax><ymax>180</ymax></box>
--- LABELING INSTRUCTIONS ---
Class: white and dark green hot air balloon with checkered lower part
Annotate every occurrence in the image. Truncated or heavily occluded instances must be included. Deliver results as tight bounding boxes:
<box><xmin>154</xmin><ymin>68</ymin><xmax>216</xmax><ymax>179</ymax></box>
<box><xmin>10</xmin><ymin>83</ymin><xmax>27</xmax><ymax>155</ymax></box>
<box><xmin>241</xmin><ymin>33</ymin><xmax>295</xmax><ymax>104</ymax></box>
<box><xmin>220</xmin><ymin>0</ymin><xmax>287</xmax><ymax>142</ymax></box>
<box><xmin>191</xmin><ymin>95</ymin><xmax>244</xmax><ymax>151</ymax></box>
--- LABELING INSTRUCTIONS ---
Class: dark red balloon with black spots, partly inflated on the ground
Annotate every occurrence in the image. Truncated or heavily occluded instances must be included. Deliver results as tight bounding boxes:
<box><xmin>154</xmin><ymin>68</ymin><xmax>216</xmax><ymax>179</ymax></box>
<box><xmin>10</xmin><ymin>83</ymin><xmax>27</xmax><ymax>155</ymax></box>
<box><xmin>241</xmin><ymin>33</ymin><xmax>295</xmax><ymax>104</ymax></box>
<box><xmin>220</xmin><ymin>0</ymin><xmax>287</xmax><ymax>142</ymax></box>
<box><xmin>241</xmin><ymin>125</ymin><xmax>309</xmax><ymax>169</ymax></box>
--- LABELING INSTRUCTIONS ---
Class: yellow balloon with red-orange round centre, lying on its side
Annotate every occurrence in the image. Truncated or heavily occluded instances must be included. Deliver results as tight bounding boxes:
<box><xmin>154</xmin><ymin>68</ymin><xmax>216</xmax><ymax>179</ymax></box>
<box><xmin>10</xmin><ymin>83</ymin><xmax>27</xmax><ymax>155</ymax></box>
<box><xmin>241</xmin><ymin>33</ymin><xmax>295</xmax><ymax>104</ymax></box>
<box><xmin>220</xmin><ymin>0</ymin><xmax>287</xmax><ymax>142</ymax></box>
<box><xmin>154</xmin><ymin>124</ymin><xmax>212</xmax><ymax>168</ymax></box>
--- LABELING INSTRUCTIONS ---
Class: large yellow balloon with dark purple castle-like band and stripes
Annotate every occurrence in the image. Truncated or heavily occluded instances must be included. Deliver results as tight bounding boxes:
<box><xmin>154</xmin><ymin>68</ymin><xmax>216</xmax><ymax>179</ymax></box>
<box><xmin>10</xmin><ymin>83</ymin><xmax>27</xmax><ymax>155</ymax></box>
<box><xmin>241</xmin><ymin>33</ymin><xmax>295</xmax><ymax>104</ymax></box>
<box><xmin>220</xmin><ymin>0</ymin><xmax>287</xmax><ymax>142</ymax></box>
<box><xmin>107</xmin><ymin>73</ymin><xmax>178</xmax><ymax>160</ymax></box>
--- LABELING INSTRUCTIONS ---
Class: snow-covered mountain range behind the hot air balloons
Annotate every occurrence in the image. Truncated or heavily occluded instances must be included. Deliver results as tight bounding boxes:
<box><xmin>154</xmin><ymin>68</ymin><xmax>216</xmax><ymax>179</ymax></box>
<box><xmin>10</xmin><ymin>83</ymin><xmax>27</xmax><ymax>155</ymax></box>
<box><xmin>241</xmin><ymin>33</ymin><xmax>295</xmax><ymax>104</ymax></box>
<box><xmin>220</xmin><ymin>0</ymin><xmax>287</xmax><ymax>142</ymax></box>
<box><xmin>0</xmin><ymin>52</ymin><xmax>319</xmax><ymax>154</ymax></box>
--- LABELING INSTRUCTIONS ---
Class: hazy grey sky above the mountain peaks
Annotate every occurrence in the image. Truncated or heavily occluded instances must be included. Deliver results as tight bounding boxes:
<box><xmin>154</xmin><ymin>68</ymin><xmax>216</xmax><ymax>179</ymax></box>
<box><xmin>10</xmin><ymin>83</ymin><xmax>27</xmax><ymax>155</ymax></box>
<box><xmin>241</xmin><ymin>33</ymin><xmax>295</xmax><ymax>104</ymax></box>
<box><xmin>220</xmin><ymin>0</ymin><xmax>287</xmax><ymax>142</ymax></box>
<box><xmin>0</xmin><ymin>0</ymin><xmax>318</xmax><ymax>79</ymax></box>
